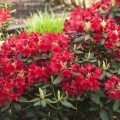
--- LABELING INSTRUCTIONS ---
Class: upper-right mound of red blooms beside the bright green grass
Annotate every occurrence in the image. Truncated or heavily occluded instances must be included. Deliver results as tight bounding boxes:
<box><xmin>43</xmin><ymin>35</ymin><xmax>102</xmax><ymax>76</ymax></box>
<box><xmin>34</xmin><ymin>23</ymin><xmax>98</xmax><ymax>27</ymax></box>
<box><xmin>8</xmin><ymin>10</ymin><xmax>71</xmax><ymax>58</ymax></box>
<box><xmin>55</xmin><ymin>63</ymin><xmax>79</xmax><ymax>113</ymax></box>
<box><xmin>64</xmin><ymin>8</ymin><xmax>120</xmax><ymax>54</ymax></box>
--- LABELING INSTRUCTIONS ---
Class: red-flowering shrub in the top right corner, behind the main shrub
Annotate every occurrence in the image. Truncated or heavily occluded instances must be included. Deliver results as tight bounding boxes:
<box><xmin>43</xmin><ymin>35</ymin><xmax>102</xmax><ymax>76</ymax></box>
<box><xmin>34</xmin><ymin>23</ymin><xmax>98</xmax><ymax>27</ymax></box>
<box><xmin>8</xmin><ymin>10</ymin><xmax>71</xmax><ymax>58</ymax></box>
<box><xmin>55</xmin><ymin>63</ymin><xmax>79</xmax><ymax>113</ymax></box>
<box><xmin>91</xmin><ymin>0</ymin><xmax>120</xmax><ymax>24</ymax></box>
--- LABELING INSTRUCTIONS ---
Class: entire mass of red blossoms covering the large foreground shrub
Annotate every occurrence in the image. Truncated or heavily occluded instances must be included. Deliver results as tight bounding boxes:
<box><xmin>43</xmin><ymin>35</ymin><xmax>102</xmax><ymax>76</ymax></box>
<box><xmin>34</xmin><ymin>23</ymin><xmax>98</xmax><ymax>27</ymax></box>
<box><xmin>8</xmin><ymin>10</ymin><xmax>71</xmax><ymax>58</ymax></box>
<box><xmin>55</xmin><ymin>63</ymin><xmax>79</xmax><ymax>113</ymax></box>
<box><xmin>0</xmin><ymin>1</ymin><xmax>120</xmax><ymax>104</ymax></box>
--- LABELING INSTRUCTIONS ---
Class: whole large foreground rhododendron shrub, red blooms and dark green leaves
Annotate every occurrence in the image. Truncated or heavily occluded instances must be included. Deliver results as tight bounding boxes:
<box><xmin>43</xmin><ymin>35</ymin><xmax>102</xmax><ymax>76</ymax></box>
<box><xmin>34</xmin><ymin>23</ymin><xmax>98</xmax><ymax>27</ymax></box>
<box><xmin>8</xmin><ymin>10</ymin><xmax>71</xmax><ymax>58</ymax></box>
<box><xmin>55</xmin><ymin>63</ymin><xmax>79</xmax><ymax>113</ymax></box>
<box><xmin>0</xmin><ymin>1</ymin><xmax>120</xmax><ymax>120</ymax></box>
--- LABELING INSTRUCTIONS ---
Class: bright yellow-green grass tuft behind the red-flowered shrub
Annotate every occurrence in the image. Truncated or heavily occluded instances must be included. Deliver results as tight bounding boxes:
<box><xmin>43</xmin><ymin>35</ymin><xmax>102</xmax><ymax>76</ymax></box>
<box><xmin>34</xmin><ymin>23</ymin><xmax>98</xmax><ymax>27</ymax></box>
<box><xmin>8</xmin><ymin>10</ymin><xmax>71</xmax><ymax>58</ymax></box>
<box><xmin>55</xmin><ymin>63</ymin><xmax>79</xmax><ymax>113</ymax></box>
<box><xmin>25</xmin><ymin>11</ymin><xmax>65</xmax><ymax>34</ymax></box>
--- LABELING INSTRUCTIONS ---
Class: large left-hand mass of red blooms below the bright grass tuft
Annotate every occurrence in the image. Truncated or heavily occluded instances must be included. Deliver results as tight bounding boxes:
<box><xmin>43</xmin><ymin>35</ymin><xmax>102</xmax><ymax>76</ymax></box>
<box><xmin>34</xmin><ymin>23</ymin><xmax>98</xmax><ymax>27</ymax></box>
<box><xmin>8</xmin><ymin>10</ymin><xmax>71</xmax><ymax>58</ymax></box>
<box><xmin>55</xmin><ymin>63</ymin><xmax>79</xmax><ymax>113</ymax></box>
<box><xmin>0</xmin><ymin>32</ymin><xmax>73</xmax><ymax>104</ymax></box>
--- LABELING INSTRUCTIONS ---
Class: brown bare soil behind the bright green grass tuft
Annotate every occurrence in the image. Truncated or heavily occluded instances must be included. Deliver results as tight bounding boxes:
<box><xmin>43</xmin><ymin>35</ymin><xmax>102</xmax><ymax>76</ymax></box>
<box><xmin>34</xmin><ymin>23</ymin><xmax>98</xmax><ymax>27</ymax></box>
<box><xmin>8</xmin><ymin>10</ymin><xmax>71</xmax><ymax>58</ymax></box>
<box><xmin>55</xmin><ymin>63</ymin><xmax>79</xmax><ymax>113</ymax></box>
<box><xmin>0</xmin><ymin>0</ymin><xmax>74</xmax><ymax>24</ymax></box>
